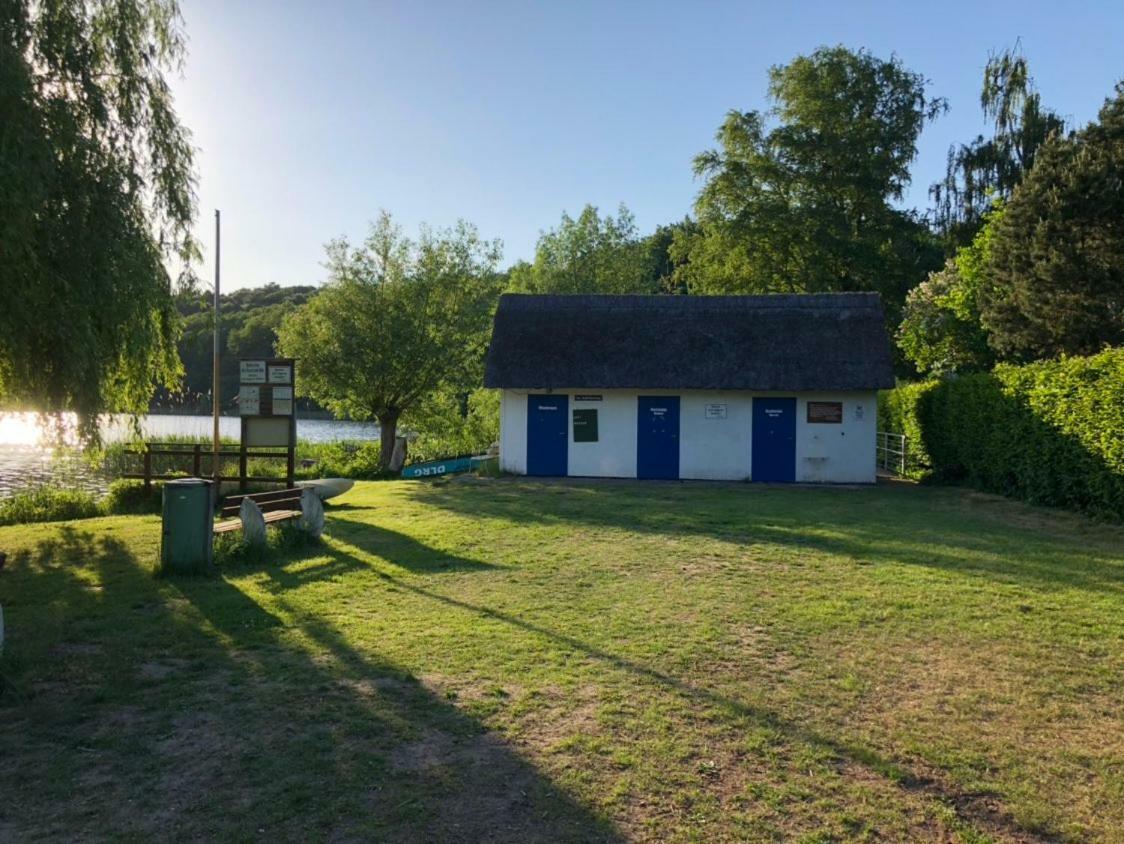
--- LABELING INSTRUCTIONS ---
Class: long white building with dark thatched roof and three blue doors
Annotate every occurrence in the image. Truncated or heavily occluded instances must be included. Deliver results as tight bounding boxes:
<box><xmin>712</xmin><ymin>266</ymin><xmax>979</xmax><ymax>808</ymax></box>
<box><xmin>484</xmin><ymin>293</ymin><xmax>894</xmax><ymax>483</ymax></box>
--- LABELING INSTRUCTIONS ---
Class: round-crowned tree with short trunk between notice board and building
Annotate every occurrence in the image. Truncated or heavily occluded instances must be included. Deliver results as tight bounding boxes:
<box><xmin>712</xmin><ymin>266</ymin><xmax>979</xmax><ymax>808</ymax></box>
<box><xmin>279</xmin><ymin>212</ymin><xmax>500</xmax><ymax>466</ymax></box>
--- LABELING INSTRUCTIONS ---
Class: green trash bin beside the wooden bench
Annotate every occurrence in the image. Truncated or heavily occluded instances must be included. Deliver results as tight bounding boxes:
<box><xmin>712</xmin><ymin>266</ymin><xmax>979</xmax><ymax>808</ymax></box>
<box><xmin>160</xmin><ymin>478</ymin><xmax>215</xmax><ymax>574</ymax></box>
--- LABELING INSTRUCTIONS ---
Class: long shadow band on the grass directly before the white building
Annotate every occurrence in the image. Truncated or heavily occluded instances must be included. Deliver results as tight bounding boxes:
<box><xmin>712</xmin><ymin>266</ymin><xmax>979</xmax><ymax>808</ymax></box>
<box><xmin>410</xmin><ymin>480</ymin><xmax>1124</xmax><ymax>593</ymax></box>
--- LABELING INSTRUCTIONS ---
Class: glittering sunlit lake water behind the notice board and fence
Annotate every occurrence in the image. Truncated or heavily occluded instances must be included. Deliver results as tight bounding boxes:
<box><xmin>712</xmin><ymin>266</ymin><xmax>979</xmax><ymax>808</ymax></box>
<box><xmin>0</xmin><ymin>414</ymin><xmax>379</xmax><ymax>498</ymax></box>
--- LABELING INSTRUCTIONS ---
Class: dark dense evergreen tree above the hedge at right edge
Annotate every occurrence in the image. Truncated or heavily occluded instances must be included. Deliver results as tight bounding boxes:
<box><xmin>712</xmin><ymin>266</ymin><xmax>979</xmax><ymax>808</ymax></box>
<box><xmin>979</xmin><ymin>83</ymin><xmax>1124</xmax><ymax>360</ymax></box>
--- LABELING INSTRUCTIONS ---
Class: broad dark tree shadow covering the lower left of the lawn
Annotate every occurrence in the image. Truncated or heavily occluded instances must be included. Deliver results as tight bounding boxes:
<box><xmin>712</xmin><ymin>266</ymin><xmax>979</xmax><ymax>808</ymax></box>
<box><xmin>0</xmin><ymin>527</ymin><xmax>620</xmax><ymax>842</ymax></box>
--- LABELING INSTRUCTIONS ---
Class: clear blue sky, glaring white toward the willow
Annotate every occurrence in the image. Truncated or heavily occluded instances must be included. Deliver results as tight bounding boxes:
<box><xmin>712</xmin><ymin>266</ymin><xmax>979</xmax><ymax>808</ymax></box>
<box><xmin>172</xmin><ymin>0</ymin><xmax>1124</xmax><ymax>290</ymax></box>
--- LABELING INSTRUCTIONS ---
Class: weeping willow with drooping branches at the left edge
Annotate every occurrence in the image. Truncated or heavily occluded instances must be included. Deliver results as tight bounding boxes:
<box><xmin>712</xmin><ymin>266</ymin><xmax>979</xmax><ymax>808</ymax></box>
<box><xmin>0</xmin><ymin>0</ymin><xmax>196</xmax><ymax>436</ymax></box>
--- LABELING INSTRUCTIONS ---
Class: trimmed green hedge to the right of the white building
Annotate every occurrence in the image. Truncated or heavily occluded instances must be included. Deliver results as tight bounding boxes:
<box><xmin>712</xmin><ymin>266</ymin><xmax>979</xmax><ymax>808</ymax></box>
<box><xmin>879</xmin><ymin>348</ymin><xmax>1124</xmax><ymax>519</ymax></box>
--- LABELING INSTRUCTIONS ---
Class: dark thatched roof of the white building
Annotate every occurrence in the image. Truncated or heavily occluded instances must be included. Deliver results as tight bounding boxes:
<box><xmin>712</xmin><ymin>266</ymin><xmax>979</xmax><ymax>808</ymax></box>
<box><xmin>484</xmin><ymin>293</ymin><xmax>894</xmax><ymax>391</ymax></box>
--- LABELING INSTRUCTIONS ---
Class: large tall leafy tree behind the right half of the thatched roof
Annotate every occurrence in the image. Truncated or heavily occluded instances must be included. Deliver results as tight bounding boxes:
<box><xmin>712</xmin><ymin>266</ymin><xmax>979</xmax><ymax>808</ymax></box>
<box><xmin>673</xmin><ymin>42</ymin><xmax>945</xmax><ymax>311</ymax></box>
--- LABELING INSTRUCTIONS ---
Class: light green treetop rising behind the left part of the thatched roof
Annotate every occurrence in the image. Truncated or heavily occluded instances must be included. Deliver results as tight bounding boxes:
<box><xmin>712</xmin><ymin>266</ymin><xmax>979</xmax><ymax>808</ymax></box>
<box><xmin>510</xmin><ymin>205</ymin><xmax>660</xmax><ymax>293</ymax></box>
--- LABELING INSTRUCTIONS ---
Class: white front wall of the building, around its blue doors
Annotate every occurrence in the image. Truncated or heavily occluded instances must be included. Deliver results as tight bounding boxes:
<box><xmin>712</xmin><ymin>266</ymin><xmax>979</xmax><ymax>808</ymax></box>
<box><xmin>500</xmin><ymin>389</ymin><xmax>878</xmax><ymax>483</ymax></box>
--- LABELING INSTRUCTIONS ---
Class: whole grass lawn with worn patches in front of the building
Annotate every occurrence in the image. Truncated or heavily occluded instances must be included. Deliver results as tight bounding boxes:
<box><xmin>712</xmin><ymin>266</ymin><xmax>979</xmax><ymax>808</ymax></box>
<box><xmin>0</xmin><ymin>479</ymin><xmax>1124</xmax><ymax>842</ymax></box>
